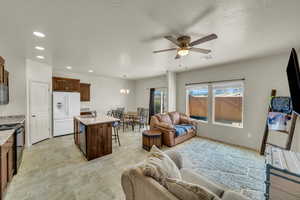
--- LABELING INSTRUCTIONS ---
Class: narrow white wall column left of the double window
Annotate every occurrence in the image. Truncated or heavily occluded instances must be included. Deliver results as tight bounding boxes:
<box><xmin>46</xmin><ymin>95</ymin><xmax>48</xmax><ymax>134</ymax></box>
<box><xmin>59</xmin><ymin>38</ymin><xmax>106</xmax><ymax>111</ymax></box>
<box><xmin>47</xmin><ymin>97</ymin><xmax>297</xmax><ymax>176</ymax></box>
<box><xmin>167</xmin><ymin>71</ymin><xmax>176</xmax><ymax>112</ymax></box>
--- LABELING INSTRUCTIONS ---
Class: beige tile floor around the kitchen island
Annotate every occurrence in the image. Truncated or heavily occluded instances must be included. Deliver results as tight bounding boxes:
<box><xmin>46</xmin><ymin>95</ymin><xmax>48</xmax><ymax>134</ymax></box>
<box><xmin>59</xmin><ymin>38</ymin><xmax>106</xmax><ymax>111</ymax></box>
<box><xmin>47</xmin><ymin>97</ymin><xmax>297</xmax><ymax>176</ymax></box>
<box><xmin>5</xmin><ymin>131</ymin><xmax>262</xmax><ymax>200</ymax></box>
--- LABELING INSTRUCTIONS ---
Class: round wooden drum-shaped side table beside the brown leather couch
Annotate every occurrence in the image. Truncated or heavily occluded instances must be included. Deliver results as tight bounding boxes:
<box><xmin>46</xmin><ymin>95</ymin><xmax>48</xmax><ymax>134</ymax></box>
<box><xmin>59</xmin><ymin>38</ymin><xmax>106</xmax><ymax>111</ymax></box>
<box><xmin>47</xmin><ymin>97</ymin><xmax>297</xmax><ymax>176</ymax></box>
<box><xmin>143</xmin><ymin>130</ymin><xmax>162</xmax><ymax>151</ymax></box>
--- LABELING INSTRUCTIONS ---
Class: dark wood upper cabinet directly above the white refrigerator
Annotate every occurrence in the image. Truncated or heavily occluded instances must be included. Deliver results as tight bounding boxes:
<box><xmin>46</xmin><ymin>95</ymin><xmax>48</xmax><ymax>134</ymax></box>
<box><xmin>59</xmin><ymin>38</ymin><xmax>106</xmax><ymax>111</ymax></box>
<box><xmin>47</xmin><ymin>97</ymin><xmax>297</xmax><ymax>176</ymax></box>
<box><xmin>52</xmin><ymin>77</ymin><xmax>80</xmax><ymax>92</ymax></box>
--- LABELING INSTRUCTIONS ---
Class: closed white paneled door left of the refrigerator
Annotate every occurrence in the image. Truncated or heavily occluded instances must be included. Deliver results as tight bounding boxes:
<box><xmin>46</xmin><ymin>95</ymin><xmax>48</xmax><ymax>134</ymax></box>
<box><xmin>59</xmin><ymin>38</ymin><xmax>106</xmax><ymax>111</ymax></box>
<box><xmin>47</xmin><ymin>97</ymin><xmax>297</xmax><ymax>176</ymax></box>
<box><xmin>29</xmin><ymin>81</ymin><xmax>50</xmax><ymax>144</ymax></box>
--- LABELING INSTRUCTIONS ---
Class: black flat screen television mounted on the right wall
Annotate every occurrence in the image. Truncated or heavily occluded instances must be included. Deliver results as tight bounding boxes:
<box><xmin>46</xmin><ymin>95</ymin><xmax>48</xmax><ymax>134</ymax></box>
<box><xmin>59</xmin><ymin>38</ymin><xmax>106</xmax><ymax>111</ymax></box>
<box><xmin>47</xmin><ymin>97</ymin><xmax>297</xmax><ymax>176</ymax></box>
<box><xmin>286</xmin><ymin>48</ymin><xmax>300</xmax><ymax>115</ymax></box>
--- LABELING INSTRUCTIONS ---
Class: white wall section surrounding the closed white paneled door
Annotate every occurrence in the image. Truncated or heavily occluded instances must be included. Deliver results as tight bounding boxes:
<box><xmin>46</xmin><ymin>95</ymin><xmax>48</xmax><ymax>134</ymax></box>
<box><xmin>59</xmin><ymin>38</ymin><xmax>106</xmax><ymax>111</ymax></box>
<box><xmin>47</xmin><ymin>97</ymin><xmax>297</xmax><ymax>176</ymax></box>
<box><xmin>25</xmin><ymin>59</ymin><xmax>52</xmax><ymax>146</ymax></box>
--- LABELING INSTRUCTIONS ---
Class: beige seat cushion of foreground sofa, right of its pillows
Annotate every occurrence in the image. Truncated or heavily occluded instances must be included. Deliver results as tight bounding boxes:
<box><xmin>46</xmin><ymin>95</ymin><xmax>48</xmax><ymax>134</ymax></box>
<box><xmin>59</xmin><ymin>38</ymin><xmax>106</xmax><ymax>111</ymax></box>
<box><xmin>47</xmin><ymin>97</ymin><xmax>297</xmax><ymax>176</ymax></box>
<box><xmin>180</xmin><ymin>168</ymin><xmax>224</xmax><ymax>197</ymax></box>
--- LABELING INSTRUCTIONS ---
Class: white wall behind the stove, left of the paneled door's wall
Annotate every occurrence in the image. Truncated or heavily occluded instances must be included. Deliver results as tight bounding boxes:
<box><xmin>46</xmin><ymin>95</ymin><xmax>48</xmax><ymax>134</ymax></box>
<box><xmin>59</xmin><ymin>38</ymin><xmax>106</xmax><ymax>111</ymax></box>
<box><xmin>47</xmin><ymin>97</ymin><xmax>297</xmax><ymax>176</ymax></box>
<box><xmin>0</xmin><ymin>50</ymin><xmax>26</xmax><ymax>116</ymax></box>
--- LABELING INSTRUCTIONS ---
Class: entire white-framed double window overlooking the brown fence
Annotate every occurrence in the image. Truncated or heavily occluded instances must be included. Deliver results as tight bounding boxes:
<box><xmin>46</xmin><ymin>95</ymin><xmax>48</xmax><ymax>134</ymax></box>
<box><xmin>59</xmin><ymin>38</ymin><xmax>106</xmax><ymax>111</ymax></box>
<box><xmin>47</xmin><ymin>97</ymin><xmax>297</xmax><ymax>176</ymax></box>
<box><xmin>186</xmin><ymin>81</ymin><xmax>244</xmax><ymax>128</ymax></box>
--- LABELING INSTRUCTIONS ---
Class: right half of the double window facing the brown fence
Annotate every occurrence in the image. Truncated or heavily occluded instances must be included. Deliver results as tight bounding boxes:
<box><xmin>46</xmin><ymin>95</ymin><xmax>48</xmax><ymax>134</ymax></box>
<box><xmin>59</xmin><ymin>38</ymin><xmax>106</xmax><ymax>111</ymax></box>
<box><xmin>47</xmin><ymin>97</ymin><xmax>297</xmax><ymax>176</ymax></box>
<box><xmin>212</xmin><ymin>81</ymin><xmax>244</xmax><ymax>128</ymax></box>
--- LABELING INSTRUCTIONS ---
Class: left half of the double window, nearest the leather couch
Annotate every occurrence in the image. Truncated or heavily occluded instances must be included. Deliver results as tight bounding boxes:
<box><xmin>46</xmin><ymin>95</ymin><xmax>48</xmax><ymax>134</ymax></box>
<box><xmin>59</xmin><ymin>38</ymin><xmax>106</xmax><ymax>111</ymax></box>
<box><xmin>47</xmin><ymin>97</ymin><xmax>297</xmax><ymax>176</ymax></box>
<box><xmin>187</xmin><ymin>85</ymin><xmax>208</xmax><ymax>122</ymax></box>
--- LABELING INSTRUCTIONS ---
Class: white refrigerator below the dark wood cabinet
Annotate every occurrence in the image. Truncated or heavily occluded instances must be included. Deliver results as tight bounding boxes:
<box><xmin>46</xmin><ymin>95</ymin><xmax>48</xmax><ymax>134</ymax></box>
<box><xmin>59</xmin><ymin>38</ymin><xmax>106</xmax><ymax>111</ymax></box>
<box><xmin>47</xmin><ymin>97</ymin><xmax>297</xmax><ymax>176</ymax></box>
<box><xmin>53</xmin><ymin>92</ymin><xmax>80</xmax><ymax>136</ymax></box>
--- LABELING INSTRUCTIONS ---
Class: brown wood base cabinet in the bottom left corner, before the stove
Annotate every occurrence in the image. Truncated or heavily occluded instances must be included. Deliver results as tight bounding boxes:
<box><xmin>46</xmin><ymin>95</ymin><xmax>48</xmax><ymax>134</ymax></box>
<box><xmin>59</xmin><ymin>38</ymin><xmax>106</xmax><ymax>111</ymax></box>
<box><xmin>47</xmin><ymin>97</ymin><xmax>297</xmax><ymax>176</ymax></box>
<box><xmin>0</xmin><ymin>136</ymin><xmax>14</xmax><ymax>200</ymax></box>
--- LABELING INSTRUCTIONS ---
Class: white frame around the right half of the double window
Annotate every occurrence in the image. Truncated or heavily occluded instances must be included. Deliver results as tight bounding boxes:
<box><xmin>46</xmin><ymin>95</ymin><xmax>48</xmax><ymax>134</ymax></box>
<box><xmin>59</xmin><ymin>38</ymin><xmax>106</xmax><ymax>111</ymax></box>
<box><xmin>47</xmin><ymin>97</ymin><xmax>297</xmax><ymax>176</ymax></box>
<box><xmin>210</xmin><ymin>81</ymin><xmax>245</xmax><ymax>129</ymax></box>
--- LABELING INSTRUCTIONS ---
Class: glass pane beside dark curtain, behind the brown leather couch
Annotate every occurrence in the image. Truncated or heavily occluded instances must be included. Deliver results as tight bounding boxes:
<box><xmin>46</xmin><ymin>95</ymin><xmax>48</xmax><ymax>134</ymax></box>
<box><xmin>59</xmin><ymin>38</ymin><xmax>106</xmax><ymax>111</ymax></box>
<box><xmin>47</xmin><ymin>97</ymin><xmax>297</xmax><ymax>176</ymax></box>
<box><xmin>154</xmin><ymin>88</ymin><xmax>167</xmax><ymax>114</ymax></box>
